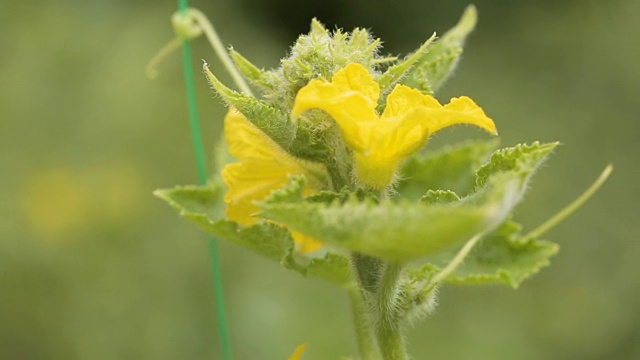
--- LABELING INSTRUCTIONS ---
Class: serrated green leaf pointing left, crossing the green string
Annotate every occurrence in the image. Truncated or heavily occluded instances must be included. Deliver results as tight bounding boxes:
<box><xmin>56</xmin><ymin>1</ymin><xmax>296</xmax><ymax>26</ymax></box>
<box><xmin>154</xmin><ymin>185</ymin><xmax>353</xmax><ymax>286</ymax></box>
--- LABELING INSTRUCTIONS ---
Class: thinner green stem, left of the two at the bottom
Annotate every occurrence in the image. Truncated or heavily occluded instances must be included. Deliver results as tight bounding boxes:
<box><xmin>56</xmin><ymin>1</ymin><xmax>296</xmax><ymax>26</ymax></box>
<box><xmin>347</xmin><ymin>284</ymin><xmax>380</xmax><ymax>360</ymax></box>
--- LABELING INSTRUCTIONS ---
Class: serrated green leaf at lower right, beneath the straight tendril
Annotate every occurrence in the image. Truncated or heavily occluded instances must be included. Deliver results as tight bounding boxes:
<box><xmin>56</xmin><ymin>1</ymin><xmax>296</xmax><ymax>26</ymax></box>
<box><xmin>439</xmin><ymin>221</ymin><xmax>559</xmax><ymax>289</ymax></box>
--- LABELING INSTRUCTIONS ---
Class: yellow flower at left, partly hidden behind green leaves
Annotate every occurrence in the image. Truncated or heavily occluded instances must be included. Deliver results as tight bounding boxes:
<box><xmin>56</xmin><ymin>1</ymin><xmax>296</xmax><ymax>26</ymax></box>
<box><xmin>222</xmin><ymin>108</ymin><xmax>326</xmax><ymax>252</ymax></box>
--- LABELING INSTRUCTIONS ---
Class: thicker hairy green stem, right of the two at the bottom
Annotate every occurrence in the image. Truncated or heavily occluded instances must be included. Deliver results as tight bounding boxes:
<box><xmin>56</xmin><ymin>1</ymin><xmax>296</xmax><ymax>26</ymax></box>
<box><xmin>373</xmin><ymin>263</ymin><xmax>409</xmax><ymax>360</ymax></box>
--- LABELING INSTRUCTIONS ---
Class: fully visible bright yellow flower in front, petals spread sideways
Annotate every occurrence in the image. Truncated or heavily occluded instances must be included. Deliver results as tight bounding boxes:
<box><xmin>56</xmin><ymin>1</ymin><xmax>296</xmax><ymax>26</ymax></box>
<box><xmin>292</xmin><ymin>63</ymin><xmax>496</xmax><ymax>189</ymax></box>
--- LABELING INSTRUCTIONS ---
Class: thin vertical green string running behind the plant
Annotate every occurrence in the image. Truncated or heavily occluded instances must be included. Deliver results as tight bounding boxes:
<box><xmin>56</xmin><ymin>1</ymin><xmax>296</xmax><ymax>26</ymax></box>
<box><xmin>178</xmin><ymin>0</ymin><xmax>231</xmax><ymax>360</ymax></box>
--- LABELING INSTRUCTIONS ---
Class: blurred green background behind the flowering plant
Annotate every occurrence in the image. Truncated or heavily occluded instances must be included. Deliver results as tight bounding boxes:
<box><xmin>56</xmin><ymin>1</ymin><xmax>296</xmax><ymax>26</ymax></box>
<box><xmin>0</xmin><ymin>0</ymin><xmax>640</xmax><ymax>360</ymax></box>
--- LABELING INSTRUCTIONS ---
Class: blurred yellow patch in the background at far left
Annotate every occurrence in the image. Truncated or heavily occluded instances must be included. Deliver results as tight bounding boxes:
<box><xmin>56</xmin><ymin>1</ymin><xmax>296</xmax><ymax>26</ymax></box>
<box><xmin>19</xmin><ymin>162</ymin><xmax>149</xmax><ymax>242</ymax></box>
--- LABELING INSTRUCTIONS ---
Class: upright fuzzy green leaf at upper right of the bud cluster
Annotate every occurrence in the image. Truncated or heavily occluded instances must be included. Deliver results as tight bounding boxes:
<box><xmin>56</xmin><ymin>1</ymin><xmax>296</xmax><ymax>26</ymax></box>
<box><xmin>402</xmin><ymin>5</ymin><xmax>478</xmax><ymax>93</ymax></box>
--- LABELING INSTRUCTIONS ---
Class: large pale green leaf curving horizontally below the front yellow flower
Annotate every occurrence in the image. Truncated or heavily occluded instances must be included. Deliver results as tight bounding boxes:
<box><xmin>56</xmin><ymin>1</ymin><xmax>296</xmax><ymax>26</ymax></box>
<box><xmin>259</xmin><ymin>143</ymin><xmax>557</xmax><ymax>262</ymax></box>
